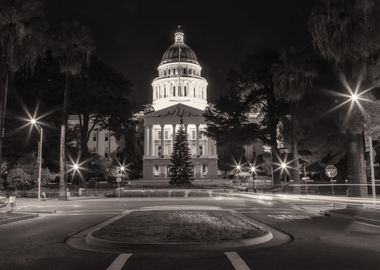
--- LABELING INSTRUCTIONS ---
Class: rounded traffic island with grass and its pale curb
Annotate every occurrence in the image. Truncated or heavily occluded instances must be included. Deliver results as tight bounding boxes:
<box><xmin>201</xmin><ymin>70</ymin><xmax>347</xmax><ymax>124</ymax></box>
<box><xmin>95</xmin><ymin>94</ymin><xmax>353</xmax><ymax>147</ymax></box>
<box><xmin>86</xmin><ymin>207</ymin><xmax>273</xmax><ymax>250</ymax></box>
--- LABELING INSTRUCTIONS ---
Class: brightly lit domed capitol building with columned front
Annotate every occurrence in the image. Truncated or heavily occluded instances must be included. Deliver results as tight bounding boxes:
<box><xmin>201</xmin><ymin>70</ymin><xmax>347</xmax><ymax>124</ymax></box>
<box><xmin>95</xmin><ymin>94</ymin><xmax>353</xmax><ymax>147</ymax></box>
<box><xmin>143</xmin><ymin>28</ymin><xmax>218</xmax><ymax>179</ymax></box>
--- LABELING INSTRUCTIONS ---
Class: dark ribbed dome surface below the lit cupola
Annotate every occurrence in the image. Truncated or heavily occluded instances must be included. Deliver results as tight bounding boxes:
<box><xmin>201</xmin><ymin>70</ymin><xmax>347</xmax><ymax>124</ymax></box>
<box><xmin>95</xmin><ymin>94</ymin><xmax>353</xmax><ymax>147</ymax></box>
<box><xmin>161</xmin><ymin>43</ymin><xmax>199</xmax><ymax>64</ymax></box>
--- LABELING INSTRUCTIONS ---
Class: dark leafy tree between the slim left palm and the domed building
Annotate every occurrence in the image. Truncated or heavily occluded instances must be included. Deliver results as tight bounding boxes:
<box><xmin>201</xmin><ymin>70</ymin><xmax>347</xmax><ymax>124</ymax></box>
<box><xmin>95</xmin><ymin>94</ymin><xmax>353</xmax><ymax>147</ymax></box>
<box><xmin>69</xmin><ymin>57</ymin><xmax>134</xmax><ymax>159</ymax></box>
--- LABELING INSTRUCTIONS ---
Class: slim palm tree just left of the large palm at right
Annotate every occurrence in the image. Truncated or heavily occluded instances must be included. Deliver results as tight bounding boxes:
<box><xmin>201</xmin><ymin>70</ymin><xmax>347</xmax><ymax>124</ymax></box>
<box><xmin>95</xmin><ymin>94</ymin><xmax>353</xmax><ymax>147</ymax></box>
<box><xmin>272</xmin><ymin>48</ymin><xmax>316</xmax><ymax>191</ymax></box>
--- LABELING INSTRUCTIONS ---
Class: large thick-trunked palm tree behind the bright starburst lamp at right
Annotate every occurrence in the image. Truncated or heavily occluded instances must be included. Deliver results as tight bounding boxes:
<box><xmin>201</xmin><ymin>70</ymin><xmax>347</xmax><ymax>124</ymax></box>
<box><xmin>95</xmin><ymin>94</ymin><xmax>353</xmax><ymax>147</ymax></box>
<box><xmin>309</xmin><ymin>0</ymin><xmax>380</xmax><ymax>196</ymax></box>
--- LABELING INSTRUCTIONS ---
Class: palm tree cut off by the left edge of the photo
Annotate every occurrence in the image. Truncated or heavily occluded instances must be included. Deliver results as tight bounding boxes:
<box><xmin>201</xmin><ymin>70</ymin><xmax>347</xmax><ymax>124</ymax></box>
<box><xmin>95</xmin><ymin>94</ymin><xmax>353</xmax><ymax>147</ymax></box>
<box><xmin>0</xmin><ymin>0</ymin><xmax>48</xmax><ymax>173</ymax></box>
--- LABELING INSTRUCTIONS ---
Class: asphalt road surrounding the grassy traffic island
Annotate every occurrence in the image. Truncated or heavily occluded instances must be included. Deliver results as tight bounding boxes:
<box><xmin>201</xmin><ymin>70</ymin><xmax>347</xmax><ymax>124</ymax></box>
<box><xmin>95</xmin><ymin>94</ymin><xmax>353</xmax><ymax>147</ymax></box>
<box><xmin>0</xmin><ymin>198</ymin><xmax>380</xmax><ymax>270</ymax></box>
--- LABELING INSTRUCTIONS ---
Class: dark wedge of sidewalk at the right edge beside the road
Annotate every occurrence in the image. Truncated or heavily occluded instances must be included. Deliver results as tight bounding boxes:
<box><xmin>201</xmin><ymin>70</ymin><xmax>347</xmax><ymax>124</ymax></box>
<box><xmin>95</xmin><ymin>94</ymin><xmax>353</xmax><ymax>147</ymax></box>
<box><xmin>324</xmin><ymin>207</ymin><xmax>380</xmax><ymax>227</ymax></box>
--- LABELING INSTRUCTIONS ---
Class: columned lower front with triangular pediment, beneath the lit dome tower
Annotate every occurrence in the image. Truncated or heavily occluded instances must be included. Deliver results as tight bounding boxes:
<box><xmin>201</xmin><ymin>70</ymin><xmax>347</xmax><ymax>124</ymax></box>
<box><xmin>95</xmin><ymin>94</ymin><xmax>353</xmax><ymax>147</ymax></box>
<box><xmin>144</xmin><ymin>104</ymin><xmax>217</xmax><ymax>179</ymax></box>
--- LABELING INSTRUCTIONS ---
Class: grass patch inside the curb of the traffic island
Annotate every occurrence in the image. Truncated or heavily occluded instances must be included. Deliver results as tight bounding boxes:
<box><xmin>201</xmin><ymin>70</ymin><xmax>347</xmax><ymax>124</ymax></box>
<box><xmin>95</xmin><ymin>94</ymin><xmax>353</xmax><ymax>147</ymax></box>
<box><xmin>93</xmin><ymin>210</ymin><xmax>266</xmax><ymax>244</ymax></box>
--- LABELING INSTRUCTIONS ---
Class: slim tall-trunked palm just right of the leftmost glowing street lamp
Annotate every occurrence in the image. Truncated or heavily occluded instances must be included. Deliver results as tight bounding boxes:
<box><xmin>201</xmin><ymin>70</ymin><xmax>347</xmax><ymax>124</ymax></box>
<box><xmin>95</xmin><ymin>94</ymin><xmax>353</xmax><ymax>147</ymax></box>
<box><xmin>52</xmin><ymin>22</ymin><xmax>95</xmax><ymax>199</ymax></box>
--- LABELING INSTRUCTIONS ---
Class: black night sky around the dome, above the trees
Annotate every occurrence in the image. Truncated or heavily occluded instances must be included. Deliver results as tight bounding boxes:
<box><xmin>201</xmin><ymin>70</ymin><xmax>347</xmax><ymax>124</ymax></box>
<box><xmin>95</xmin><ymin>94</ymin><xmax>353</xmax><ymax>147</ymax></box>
<box><xmin>40</xmin><ymin>0</ymin><xmax>313</xmax><ymax>108</ymax></box>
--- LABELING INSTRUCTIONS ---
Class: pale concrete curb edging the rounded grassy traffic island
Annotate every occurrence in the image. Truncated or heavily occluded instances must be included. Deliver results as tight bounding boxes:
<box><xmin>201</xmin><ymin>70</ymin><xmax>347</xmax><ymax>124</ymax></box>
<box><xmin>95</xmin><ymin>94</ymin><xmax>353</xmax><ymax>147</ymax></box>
<box><xmin>85</xmin><ymin>209</ymin><xmax>273</xmax><ymax>250</ymax></box>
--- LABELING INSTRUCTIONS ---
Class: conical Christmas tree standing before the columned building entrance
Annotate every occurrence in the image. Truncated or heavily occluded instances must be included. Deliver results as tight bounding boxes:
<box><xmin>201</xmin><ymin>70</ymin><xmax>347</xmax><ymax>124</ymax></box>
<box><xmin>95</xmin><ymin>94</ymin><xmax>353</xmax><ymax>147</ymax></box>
<box><xmin>169</xmin><ymin>119</ymin><xmax>193</xmax><ymax>186</ymax></box>
